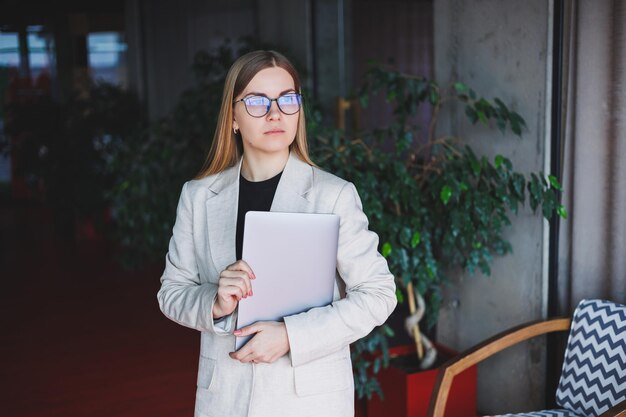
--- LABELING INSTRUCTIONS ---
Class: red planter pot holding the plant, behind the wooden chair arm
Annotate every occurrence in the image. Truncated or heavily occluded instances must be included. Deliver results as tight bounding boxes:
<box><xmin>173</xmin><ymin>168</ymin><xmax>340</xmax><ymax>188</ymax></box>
<box><xmin>362</xmin><ymin>345</ymin><xmax>476</xmax><ymax>417</ymax></box>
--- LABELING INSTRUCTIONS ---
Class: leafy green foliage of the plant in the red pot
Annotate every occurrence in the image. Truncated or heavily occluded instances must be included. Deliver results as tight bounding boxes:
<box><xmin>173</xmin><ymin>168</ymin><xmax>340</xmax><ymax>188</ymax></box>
<box><xmin>313</xmin><ymin>66</ymin><xmax>566</xmax><ymax>398</ymax></box>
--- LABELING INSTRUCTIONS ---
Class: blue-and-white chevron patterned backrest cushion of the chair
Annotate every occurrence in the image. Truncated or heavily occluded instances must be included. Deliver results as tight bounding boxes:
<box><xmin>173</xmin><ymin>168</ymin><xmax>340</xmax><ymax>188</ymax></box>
<box><xmin>556</xmin><ymin>300</ymin><xmax>626</xmax><ymax>417</ymax></box>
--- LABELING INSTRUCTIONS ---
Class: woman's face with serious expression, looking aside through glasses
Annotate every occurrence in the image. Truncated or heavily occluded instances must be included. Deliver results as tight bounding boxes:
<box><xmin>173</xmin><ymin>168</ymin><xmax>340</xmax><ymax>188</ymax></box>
<box><xmin>233</xmin><ymin>67</ymin><xmax>302</xmax><ymax>156</ymax></box>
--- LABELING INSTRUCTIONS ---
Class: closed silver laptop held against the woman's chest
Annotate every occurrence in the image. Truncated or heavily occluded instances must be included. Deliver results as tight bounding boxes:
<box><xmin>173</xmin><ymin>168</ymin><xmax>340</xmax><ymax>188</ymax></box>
<box><xmin>235</xmin><ymin>211</ymin><xmax>339</xmax><ymax>349</ymax></box>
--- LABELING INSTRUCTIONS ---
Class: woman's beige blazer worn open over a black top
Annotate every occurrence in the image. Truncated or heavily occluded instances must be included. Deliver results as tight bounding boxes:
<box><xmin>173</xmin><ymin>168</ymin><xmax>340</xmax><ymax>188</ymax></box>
<box><xmin>157</xmin><ymin>155</ymin><xmax>396</xmax><ymax>417</ymax></box>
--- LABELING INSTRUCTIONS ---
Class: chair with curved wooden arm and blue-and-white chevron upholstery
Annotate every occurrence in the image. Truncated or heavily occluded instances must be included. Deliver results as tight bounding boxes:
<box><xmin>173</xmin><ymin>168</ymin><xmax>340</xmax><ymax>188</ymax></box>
<box><xmin>428</xmin><ymin>300</ymin><xmax>626</xmax><ymax>417</ymax></box>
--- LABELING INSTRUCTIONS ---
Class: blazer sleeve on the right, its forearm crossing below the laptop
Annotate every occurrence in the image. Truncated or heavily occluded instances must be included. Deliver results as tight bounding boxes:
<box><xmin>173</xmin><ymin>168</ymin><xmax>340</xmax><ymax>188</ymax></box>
<box><xmin>284</xmin><ymin>183</ymin><xmax>397</xmax><ymax>366</ymax></box>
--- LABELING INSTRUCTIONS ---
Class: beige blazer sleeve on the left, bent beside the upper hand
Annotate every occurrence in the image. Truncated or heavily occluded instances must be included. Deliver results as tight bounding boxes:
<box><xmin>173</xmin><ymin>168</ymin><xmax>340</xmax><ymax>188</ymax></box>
<box><xmin>157</xmin><ymin>182</ymin><xmax>235</xmax><ymax>335</ymax></box>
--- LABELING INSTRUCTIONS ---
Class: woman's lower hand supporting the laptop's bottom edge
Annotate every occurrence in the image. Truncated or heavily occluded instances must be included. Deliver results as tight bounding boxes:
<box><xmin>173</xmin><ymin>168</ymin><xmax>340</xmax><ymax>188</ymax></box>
<box><xmin>229</xmin><ymin>321</ymin><xmax>289</xmax><ymax>363</ymax></box>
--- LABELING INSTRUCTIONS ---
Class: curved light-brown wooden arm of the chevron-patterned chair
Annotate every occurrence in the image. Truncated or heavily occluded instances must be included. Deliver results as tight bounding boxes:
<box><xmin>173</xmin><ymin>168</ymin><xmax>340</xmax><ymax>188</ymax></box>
<box><xmin>428</xmin><ymin>318</ymin><xmax>572</xmax><ymax>417</ymax></box>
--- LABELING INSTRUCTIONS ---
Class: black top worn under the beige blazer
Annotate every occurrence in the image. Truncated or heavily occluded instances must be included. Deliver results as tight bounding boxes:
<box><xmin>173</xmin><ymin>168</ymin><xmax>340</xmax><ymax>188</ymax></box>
<box><xmin>235</xmin><ymin>172</ymin><xmax>282</xmax><ymax>260</ymax></box>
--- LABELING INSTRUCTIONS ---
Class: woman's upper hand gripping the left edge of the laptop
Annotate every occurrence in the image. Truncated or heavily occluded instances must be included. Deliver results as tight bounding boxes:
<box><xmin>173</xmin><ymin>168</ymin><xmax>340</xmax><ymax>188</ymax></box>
<box><xmin>213</xmin><ymin>260</ymin><xmax>256</xmax><ymax>318</ymax></box>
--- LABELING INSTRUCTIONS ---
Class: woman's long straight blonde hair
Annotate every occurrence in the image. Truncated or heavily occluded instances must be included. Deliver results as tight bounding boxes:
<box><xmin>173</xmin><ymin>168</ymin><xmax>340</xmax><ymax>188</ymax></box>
<box><xmin>196</xmin><ymin>51</ymin><xmax>315</xmax><ymax>179</ymax></box>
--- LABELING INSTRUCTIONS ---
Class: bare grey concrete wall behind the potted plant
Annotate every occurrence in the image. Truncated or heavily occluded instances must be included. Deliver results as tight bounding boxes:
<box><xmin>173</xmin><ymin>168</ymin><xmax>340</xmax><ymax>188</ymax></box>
<box><xmin>435</xmin><ymin>0</ymin><xmax>551</xmax><ymax>414</ymax></box>
